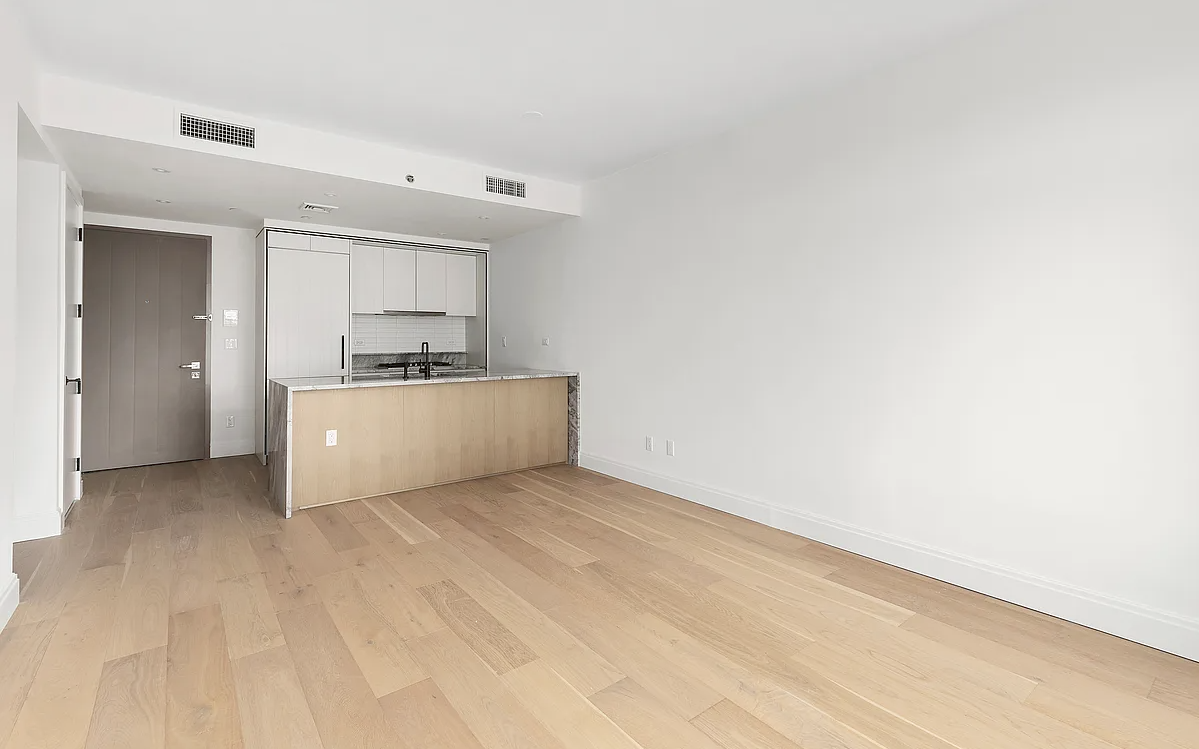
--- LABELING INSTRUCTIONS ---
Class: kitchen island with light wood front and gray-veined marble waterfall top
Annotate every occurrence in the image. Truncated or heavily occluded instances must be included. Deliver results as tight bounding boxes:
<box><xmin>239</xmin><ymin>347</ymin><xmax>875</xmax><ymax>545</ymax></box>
<box><xmin>266</xmin><ymin>369</ymin><xmax>579</xmax><ymax>518</ymax></box>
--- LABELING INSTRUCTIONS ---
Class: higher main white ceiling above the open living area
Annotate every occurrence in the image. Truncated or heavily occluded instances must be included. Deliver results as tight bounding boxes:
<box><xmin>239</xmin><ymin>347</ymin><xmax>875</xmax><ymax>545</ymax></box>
<box><xmin>19</xmin><ymin>0</ymin><xmax>1023</xmax><ymax>181</ymax></box>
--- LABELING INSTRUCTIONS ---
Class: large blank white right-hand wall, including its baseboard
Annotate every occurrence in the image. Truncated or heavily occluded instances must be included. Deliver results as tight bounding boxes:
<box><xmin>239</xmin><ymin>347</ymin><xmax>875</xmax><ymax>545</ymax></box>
<box><xmin>492</xmin><ymin>0</ymin><xmax>1199</xmax><ymax>658</ymax></box>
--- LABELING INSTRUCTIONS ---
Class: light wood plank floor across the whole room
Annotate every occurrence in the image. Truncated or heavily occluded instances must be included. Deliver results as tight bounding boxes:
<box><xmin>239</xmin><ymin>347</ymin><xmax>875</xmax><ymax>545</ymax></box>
<box><xmin>0</xmin><ymin>458</ymin><xmax>1199</xmax><ymax>749</ymax></box>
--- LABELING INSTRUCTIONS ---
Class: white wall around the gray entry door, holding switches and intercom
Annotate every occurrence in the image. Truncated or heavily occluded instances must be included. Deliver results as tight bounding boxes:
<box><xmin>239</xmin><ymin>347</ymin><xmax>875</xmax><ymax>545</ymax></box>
<box><xmin>83</xmin><ymin>212</ymin><xmax>255</xmax><ymax>458</ymax></box>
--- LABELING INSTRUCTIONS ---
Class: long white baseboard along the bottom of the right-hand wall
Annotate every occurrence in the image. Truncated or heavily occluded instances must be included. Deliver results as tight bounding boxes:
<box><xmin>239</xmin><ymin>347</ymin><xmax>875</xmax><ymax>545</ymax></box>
<box><xmin>579</xmin><ymin>454</ymin><xmax>1199</xmax><ymax>660</ymax></box>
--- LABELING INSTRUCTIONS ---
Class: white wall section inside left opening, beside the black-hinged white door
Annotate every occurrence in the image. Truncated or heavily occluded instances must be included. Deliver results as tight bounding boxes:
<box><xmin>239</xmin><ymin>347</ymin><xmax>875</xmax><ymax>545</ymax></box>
<box><xmin>12</xmin><ymin>159</ymin><xmax>64</xmax><ymax>540</ymax></box>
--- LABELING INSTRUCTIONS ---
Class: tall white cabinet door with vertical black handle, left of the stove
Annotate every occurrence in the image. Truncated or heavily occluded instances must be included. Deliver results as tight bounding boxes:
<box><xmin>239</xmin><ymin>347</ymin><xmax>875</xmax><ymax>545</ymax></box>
<box><xmin>266</xmin><ymin>248</ymin><xmax>350</xmax><ymax>377</ymax></box>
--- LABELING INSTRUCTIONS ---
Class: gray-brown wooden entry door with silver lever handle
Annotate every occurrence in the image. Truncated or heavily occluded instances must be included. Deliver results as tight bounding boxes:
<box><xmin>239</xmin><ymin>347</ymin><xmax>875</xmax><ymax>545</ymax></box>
<box><xmin>83</xmin><ymin>226</ymin><xmax>209</xmax><ymax>471</ymax></box>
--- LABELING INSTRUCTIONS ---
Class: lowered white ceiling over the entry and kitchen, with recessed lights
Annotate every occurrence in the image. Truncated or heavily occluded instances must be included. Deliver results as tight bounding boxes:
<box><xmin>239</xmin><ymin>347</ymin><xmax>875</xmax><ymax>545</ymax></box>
<box><xmin>51</xmin><ymin>126</ymin><xmax>565</xmax><ymax>242</ymax></box>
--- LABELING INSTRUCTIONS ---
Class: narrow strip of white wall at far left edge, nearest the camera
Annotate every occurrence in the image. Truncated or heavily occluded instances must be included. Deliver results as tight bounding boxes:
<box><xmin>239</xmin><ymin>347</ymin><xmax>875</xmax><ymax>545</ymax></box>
<box><xmin>0</xmin><ymin>0</ymin><xmax>36</xmax><ymax>626</ymax></box>
